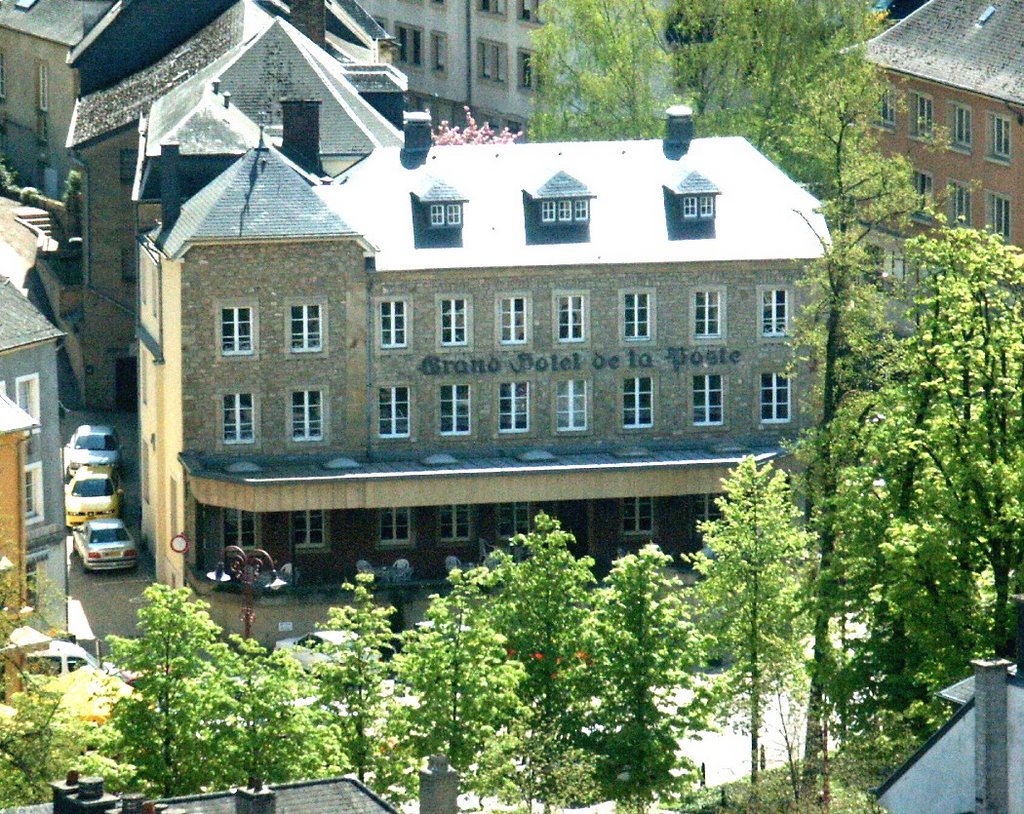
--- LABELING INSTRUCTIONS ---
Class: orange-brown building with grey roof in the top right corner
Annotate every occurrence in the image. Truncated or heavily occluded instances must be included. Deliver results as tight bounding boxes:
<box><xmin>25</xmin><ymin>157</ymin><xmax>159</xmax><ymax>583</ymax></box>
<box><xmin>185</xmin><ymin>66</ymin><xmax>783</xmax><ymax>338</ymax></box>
<box><xmin>866</xmin><ymin>0</ymin><xmax>1024</xmax><ymax>245</ymax></box>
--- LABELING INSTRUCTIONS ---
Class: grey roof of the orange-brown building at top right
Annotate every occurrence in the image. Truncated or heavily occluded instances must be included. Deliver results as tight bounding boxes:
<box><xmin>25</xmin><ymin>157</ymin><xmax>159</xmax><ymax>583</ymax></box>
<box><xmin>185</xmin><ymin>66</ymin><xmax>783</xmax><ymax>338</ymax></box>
<box><xmin>865</xmin><ymin>0</ymin><xmax>1024</xmax><ymax>102</ymax></box>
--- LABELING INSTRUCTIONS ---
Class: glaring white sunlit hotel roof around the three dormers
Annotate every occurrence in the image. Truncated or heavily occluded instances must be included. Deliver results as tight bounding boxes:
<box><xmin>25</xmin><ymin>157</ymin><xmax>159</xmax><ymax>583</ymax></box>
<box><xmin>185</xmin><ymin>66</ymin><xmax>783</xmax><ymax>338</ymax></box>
<box><xmin>315</xmin><ymin>137</ymin><xmax>827</xmax><ymax>272</ymax></box>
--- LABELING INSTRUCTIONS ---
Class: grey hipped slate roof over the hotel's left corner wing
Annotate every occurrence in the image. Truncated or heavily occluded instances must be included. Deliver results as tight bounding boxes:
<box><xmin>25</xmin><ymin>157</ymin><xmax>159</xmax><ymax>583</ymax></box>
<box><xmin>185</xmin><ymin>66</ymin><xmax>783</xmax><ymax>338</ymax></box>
<box><xmin>157</xmin><ymin>146</ymin><xmax>354</xmax><ymax>257</ymax></box>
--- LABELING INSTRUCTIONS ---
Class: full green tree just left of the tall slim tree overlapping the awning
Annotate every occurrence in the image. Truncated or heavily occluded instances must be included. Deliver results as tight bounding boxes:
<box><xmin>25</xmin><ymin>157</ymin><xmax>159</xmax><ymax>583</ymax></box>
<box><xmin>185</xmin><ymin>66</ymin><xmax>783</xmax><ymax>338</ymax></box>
<box><xmin>589</xmin><ymin>545</ymin><xmax>707</xmax><ymax>813</ymax></box>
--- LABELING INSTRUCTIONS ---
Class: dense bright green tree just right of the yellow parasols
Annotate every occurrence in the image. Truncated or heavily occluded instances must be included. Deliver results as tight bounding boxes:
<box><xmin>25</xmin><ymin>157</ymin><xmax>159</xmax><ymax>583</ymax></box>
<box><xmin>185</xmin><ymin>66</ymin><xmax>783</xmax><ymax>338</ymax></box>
<box><xmin>111</xmin><ymin>584</ymin><xmax>234</xmax><ymax>797</ymax></box>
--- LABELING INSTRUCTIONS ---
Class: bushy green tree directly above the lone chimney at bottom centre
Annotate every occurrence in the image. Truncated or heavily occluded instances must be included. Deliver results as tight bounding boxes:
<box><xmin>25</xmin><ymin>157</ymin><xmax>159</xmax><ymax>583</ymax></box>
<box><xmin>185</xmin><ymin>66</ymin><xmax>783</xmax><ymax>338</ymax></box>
<box><xmin>395</xmin><ymin>568</ymin><xmax>523</xmax><ymax>785</ymax></box>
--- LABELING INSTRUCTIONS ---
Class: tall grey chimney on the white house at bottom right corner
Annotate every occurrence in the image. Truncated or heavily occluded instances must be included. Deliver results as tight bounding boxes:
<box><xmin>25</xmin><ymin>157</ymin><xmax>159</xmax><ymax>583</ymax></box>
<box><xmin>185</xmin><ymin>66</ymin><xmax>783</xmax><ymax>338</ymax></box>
<box><xmin>971</xmin><ymin>658</ymin><xmax>1010</xmax><ymax>814</ymax></box>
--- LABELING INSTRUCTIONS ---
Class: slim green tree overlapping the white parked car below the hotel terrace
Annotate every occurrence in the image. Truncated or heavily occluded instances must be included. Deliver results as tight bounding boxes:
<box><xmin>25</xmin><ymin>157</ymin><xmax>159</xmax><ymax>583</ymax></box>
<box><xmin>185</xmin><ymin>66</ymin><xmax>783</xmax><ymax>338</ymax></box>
<box><xmin>313</xmin><ymin>574</ymin><xmax>410</xmax><ymax>799</ymax></box>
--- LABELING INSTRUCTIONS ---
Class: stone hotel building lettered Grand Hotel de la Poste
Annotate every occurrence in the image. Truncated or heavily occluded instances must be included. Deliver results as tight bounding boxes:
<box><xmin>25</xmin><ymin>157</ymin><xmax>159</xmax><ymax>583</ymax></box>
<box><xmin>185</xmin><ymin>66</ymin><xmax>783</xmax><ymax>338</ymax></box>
<box><xmin>139</xmin><ymin>105</ymin><xmax>826</xmax><ymax>630</ymax></box>
